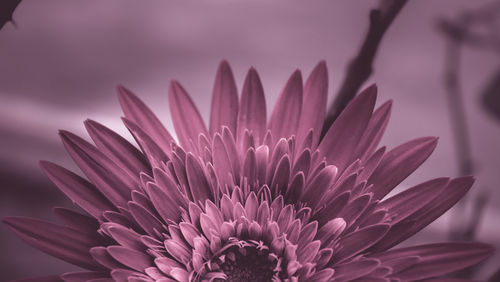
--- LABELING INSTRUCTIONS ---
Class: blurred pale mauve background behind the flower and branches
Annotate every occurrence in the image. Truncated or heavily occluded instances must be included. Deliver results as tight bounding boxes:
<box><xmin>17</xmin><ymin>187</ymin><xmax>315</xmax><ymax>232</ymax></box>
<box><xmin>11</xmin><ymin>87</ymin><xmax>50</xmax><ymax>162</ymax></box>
<box><xmin>0</xmin><ymin>0</ymin><xmax>500</xmax><ymax>281</ymax></box>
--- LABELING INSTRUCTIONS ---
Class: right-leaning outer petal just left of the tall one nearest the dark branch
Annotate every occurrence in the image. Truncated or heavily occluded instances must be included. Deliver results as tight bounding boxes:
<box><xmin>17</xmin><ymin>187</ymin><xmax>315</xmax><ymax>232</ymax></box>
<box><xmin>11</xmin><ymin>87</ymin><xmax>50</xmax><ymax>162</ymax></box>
<box><xmin>268</xmin><ymin>70</ymin><xmax>302</xmax><ymax>140</ymax></box>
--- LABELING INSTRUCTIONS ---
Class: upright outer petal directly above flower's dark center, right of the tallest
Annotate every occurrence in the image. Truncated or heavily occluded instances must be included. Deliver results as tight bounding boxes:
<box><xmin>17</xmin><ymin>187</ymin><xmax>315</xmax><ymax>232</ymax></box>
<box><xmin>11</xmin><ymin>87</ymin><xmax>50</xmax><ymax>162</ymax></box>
<box><xmin>237</xmin><ymin>68</ymin><xmax>267</xmax><ymax>144</ymax></box>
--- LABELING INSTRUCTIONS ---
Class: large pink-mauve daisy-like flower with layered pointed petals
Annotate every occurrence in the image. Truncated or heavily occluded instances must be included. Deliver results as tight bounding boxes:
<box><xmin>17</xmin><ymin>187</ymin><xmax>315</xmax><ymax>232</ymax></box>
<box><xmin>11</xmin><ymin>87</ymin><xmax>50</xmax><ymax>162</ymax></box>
<box><xmin>5</xmin><ymin>62</ymin><xmax>492</xmax><ymax>282</ymax></box>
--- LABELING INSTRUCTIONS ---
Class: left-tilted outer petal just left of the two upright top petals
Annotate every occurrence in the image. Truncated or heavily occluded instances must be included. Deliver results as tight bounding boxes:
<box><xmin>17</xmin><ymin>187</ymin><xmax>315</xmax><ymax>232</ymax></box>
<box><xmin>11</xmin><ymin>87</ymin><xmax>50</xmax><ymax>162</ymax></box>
<box><xmin>168</xmin><ymin>80</ymin><xmax>209</xmax><ymax>152</ymax></box>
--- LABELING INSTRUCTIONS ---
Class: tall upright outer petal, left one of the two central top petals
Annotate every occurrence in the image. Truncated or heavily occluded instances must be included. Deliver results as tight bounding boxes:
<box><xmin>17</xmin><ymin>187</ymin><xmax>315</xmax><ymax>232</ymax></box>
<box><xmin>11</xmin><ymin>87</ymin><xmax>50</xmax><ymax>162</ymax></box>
<box><xmin>210</xmin><ymin>60</ymin><xmax>238</xmax><ymax>136</ymax></box>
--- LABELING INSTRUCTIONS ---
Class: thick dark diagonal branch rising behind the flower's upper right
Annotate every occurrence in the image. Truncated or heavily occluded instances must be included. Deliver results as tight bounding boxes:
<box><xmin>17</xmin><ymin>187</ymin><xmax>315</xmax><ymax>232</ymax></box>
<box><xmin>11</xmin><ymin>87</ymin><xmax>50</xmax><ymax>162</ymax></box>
<box><xmin>322</xmin><ymin>0</ymin><xmax>407</xmax><ymax>136</ymax></box>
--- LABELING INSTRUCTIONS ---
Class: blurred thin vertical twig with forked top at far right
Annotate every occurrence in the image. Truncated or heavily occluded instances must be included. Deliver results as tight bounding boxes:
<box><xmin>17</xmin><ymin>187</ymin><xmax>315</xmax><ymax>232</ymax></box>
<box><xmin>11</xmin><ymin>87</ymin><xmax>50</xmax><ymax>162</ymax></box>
<box><xmin>438</xmin><ymin>3</ymin><xmax>500</xmax><ymax>278</ymax></box>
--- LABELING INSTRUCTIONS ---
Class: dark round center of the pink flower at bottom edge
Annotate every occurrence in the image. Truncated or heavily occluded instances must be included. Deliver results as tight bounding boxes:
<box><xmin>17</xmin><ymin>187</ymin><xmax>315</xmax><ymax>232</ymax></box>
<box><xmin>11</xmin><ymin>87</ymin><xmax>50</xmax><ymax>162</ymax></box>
<box><xmin>216</xmin><ymin>247</ymin><xmax>279</xmax><ymax>282</ymax></box>
